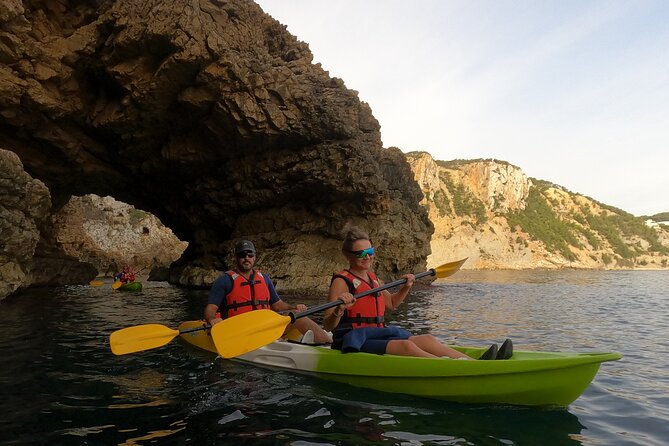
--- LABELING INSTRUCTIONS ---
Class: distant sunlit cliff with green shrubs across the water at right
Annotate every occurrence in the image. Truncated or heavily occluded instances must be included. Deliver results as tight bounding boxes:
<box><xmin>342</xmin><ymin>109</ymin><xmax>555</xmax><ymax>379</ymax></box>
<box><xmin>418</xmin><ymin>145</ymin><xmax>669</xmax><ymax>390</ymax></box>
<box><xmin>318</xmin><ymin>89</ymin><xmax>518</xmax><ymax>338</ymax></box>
<box><xmin>408</xmin><ymin>152</ymin><xmax>669</xmax><ymax>269</ymax></box>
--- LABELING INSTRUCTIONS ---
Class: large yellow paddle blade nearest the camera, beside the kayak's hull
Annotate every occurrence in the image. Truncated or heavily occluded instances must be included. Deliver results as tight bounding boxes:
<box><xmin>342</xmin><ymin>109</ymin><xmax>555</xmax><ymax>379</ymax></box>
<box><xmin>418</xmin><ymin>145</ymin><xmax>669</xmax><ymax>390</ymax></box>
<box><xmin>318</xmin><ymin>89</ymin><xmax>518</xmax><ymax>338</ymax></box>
<box><xmin>211</xmin><ymin>310</ymin><xmax>291</xmax><ymax>358</ymax></box>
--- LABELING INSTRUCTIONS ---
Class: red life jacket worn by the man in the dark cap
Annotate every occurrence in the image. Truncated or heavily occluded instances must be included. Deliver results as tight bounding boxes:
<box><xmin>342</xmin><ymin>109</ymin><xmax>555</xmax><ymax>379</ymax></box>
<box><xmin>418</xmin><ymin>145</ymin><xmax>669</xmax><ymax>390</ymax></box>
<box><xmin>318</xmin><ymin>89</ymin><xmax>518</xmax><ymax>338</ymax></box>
<box><xmin>225</xmin><ymin>270</ymin><xmax>269</xmax><ymax>317</ymax></box>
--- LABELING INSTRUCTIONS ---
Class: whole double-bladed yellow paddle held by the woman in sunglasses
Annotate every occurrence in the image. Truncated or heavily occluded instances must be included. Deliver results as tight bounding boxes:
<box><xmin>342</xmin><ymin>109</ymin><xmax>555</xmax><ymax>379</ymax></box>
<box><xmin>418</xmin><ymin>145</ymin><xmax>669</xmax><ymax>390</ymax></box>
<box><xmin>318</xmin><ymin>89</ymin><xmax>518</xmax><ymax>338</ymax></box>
<box><xmin>211</xmin><ymin>258</ymin><xmax>467</xmax><ymax>358</ymax></box>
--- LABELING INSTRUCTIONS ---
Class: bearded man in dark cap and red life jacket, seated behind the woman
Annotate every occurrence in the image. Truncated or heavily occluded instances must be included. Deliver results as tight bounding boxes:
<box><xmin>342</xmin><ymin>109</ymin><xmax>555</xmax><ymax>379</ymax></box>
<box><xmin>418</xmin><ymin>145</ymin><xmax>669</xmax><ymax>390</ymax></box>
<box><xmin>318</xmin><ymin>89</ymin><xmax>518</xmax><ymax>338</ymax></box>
<box><xmin>204</xmin><ymin>240</ymin><xmax>342</xmax><ymax>344</ymax></box>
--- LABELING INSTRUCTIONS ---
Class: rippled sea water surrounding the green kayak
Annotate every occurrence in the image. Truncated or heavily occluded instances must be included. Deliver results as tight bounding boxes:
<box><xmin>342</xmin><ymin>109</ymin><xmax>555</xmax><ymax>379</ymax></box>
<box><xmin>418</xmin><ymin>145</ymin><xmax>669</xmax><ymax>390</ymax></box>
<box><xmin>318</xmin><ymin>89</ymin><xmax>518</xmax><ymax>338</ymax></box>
<box><xmin>0</xmin><ymin>271</ymin><xmax>669</xmax><ymax>445</ymax></box>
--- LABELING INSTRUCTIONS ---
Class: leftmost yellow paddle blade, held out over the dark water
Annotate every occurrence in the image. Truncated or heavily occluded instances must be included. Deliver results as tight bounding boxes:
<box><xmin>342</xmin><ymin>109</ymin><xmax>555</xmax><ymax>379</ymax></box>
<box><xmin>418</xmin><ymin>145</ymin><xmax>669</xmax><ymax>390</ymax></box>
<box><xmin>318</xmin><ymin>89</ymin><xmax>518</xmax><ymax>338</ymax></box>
<box><xmin>109</xmin><ymin>324</ymin><xmax>179</xmax><ymax>355</ymax></box>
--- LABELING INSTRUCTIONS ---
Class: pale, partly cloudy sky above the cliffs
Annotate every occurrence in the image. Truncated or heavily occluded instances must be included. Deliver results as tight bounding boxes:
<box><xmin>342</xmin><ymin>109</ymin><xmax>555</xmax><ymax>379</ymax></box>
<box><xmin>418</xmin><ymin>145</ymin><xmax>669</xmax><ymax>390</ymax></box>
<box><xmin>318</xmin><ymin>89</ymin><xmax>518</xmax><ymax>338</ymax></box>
<box><xmin>257</xmin><ymin>0</ymin><xmax>669</xmax><ymax>215</ymax></box>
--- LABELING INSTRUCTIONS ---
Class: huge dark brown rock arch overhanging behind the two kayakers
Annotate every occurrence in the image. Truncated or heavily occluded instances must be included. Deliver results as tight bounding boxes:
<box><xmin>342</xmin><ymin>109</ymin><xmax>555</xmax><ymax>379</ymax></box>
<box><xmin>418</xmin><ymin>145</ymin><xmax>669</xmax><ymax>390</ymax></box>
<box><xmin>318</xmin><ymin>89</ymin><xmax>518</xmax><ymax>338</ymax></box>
<box><xmin>0</xmin><ymin>0</ymin><xmax>432</xmax><ymax>290</ymax></box>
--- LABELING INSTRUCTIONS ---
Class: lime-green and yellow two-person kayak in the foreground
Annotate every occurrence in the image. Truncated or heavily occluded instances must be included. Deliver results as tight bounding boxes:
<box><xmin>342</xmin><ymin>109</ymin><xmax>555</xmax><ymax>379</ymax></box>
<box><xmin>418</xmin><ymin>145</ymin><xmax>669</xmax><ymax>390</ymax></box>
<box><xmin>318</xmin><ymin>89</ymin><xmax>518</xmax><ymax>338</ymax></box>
<box><xmin>179</xmin><ymin>321</ymin><xmax>622</xmax><ymax>406</ymax></box>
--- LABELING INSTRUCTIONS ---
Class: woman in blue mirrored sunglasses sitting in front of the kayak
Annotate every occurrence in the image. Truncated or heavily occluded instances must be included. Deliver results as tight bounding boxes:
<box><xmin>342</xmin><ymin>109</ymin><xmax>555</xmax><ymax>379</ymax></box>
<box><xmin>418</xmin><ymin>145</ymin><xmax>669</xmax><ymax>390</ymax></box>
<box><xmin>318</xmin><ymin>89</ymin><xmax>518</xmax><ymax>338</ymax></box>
<box><xmin>323</xmin><ymin>226</ymin><xmax>513</xmax><ymax>359</ymax></box>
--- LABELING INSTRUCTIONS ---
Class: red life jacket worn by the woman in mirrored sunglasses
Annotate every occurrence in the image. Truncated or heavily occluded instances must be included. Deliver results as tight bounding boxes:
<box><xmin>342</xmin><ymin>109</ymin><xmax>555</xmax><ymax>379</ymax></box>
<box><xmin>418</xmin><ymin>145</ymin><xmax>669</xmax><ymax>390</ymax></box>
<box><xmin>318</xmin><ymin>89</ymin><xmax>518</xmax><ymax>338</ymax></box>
<box><xmin>330</xmin><ymin>270</ymin><xmax>386</xmax><ymax>328</ymax></box>
